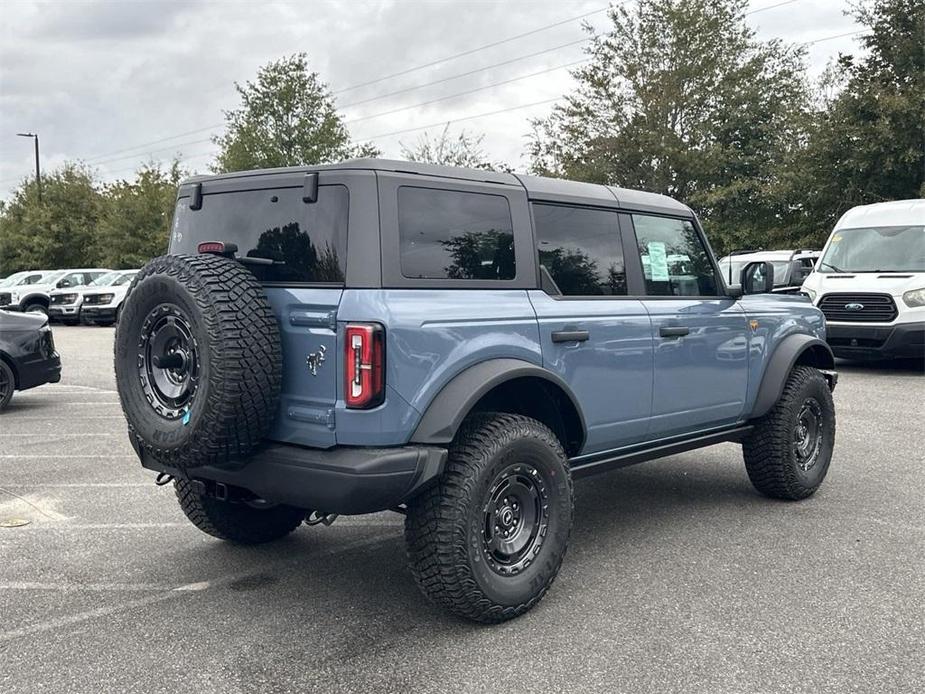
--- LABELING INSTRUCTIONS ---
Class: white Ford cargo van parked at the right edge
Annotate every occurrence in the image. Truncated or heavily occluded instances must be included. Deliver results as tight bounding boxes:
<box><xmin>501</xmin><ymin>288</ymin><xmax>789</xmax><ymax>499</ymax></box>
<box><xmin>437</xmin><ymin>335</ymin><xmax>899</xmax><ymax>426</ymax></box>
<box><xmin>802</xmin><ymin>200</ymin><xmax>925</xmax><ymax>359</ymax></box>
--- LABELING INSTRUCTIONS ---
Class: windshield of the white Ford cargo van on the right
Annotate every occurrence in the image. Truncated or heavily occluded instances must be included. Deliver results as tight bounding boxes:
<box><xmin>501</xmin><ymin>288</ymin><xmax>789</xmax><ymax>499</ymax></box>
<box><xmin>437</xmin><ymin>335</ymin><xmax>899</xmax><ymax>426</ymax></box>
<box><xmin>817</xmin><ymin>224</ymin><xmax>925</xmax><ymax>273</ymax></box>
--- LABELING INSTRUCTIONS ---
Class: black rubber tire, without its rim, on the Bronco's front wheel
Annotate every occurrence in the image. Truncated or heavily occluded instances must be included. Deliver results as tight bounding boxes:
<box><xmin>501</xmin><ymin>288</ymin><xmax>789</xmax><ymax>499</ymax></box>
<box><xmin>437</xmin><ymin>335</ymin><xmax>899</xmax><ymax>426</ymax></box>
<box><xmin>742</xmin><ymin>366</ymin><xmax>835</xmax><ymax>501</ymax></box>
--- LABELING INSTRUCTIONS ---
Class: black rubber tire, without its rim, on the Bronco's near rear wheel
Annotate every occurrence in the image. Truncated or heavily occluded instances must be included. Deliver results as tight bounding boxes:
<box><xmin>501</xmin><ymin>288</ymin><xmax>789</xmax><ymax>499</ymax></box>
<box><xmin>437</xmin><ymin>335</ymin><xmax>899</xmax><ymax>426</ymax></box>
<box><xmin>405</xmin><ymin>413</ymin><xmax>573</xmax><ymax>622</ymax></box>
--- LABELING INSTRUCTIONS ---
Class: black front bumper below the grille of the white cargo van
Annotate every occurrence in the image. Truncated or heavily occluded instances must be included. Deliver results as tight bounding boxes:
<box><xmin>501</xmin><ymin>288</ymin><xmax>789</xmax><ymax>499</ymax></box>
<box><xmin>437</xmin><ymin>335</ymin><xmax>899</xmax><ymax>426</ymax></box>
<box><xmin>826</xmin><ymin>322</ymin><xmax>925</xmax><ymax>359</ymax></box>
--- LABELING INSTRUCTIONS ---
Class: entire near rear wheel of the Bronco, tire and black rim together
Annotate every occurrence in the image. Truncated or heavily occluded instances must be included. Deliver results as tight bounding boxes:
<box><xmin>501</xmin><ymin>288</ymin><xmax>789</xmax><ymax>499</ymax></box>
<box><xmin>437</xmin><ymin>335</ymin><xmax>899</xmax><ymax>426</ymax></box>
<box><xmin>405</xmin><ymin>413</ymin><xmax>573</xmax><ymax>622</ymax></box>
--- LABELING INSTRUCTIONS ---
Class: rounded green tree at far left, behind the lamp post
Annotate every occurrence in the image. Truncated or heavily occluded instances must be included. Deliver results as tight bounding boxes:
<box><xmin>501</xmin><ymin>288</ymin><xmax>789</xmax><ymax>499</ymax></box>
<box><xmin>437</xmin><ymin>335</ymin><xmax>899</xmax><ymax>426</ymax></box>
<box><xmin>0</xmin><ymin>163</ymin><xmax>103</xmax><ymax>276</ymax></box>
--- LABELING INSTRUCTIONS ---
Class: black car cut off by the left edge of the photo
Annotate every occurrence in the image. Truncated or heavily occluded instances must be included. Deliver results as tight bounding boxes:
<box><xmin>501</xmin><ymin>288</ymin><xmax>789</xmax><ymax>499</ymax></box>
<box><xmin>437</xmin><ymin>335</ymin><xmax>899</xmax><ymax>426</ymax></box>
<box><xmin>0</xmin><ymin>311</ymin><xmax>61</xmax><ymax>410</ymax></box>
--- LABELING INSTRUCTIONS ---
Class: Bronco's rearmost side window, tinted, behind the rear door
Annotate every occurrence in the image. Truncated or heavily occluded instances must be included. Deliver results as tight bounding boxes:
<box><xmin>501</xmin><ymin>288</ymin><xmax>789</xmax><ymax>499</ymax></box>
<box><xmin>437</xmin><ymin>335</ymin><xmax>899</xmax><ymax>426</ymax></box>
<box><xmin>398</xmin><ymin>186</ymin><xmax>516</xmax><ymax>280</ymax></box>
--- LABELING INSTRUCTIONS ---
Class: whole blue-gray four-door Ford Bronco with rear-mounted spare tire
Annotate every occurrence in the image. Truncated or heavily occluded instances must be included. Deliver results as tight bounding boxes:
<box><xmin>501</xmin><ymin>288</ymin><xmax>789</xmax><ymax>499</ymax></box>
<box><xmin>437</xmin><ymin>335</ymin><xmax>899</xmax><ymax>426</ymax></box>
<box><xmin>115</xmin><ymin>160</ymin><xmax>836</xmax><ymax>622</ymax></box>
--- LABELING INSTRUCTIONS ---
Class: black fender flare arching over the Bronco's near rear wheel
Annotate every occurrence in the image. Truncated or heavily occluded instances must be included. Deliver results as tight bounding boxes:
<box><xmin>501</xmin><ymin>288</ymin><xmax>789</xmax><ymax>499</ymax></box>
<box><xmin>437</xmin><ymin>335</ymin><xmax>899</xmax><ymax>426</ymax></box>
<box><xmin>411</xmin><ymin>359</ymin><xmax>587</xmax><ymax>452</ymax></box>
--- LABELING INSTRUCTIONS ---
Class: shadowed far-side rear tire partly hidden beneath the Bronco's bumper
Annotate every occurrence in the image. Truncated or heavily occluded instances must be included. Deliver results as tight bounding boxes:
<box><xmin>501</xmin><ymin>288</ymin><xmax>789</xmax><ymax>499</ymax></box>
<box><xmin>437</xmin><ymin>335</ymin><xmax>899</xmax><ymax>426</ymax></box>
<box><xmin>174</xmin><ymin>480</ymin><xmax>305</xmax><ymax>545</ymax></box>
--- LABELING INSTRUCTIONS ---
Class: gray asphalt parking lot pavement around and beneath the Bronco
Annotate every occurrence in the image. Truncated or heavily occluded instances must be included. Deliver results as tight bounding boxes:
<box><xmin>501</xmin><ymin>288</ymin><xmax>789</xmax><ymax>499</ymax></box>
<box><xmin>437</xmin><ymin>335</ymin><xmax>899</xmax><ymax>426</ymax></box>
<box><xmin>0</xmin><ymin>327</ymin><xmax>925</xmax><ymax>694</ymax></box>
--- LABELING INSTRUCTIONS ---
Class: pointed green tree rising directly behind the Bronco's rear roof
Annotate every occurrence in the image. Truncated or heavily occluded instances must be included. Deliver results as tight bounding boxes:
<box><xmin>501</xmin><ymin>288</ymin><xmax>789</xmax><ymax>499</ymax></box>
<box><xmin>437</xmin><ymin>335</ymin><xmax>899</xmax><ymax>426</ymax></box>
<box><xmin>213</xmin><ymin>53</ymin><xmax>378</xmax><ymax>172</ymax></box>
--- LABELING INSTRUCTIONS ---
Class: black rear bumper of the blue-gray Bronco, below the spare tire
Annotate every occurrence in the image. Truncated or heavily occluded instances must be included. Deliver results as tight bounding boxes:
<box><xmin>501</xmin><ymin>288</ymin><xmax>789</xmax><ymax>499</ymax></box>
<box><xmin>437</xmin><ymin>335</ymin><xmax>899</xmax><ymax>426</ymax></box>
<box><xmin>141</xmin><ymin>444</ymin><xmax>447</xmax><ymax>514</ymax></box>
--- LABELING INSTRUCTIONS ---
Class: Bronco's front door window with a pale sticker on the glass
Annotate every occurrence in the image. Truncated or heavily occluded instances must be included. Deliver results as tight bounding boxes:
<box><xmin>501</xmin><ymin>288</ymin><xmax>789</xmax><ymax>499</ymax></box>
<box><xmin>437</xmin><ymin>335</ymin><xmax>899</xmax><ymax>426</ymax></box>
<box><xmin>633</xmin><ymin>214</ymin><xmax>717</xmax><ymax>296</ymax></box>
